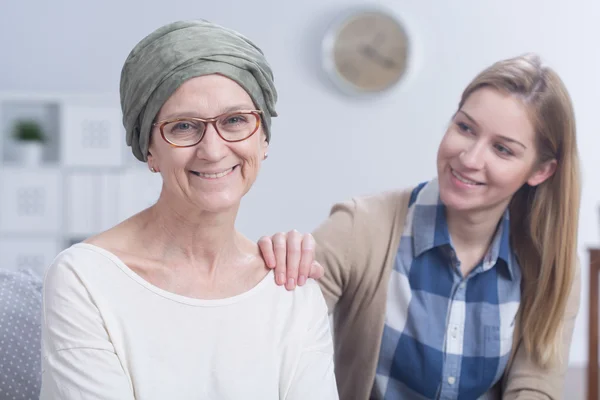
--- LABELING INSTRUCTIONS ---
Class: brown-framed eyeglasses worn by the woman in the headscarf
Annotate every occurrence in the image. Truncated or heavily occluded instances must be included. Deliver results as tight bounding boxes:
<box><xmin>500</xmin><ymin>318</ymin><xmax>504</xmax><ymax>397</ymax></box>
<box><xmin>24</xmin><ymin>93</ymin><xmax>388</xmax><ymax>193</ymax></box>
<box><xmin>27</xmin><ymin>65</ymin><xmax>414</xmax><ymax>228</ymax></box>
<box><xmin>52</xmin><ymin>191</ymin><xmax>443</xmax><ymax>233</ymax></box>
<box><xmin>152</xmin><ymin>110</ymin><xmax>262</xmax><ymax>147</ymax></box>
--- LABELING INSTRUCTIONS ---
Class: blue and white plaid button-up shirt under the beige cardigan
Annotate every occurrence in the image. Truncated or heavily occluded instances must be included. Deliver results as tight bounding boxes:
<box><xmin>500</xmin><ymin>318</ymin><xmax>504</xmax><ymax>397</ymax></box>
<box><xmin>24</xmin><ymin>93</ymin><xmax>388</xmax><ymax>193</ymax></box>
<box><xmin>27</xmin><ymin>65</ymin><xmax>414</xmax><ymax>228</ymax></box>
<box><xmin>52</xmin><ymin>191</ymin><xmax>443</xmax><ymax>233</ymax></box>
<box><xmin>373</xmin><ymin>179</ymin><xmax>521</xmax><ymax>400</ymax></box>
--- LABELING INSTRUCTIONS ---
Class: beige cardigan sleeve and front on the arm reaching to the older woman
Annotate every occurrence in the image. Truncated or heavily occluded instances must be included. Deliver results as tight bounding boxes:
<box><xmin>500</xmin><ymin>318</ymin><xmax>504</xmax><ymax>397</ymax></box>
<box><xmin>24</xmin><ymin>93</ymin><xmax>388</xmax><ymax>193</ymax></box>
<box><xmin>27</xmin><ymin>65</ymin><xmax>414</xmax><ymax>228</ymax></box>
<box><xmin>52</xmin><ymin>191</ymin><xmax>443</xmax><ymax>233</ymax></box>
<box><xmin>313</xmin><ymin>190</ymin><xmax>410</xmax><ymax>399</ymax></box>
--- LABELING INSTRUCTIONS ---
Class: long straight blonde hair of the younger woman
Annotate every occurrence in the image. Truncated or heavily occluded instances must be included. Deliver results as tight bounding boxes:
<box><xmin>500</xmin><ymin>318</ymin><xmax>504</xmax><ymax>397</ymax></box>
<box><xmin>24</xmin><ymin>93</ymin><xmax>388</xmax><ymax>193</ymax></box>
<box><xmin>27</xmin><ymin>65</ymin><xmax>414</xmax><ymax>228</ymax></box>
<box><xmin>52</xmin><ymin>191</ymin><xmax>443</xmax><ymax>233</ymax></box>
<box><xmin>459</xmin><ymin>54</ymin><xmax>580</xmax><ymax>366</ymax></box>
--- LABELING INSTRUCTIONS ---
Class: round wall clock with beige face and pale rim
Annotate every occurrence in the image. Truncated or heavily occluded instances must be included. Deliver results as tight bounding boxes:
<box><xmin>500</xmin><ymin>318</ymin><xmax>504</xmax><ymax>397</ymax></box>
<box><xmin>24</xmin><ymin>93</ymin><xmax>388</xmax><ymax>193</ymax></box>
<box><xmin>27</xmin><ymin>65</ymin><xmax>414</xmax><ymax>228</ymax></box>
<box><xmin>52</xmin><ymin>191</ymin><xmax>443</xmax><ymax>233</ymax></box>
<box><xmin>325</xmin><ymin>11</ymin><xmax>408</xmax><ymax>92</ymax></box>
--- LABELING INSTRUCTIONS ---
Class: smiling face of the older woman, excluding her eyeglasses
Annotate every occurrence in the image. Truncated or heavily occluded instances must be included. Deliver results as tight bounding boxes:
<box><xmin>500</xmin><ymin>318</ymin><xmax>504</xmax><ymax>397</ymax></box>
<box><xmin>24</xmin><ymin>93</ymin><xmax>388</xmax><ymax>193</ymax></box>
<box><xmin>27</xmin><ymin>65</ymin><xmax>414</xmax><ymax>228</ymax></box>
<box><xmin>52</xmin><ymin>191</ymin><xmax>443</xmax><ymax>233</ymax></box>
<box><xmin>148</xmin><ymin>75</ymin><xmax>268</xmax><ymax>212</ymax></box>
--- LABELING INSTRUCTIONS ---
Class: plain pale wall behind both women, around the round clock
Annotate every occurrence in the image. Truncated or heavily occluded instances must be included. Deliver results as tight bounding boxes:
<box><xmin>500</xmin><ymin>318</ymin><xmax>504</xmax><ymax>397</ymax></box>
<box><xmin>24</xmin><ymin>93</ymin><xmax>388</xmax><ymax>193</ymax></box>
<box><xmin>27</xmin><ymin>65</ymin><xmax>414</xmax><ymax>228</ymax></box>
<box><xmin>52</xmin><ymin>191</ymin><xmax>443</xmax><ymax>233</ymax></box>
<box><xmin>0</xmin><ymin>0</ymin><xmax>600</xmax><ymax>364</ymax></box>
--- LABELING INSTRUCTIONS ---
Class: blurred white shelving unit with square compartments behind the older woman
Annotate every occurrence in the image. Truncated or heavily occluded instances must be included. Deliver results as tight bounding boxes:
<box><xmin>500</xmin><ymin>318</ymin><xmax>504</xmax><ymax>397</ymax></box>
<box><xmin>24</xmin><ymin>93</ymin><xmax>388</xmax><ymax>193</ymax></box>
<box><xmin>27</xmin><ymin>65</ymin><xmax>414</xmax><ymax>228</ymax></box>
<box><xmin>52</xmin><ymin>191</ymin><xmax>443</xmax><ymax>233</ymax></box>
<box><xmin>0</xmin><ymin>92</ymin><xmax>162</xmax><ymax>275</ymax></box>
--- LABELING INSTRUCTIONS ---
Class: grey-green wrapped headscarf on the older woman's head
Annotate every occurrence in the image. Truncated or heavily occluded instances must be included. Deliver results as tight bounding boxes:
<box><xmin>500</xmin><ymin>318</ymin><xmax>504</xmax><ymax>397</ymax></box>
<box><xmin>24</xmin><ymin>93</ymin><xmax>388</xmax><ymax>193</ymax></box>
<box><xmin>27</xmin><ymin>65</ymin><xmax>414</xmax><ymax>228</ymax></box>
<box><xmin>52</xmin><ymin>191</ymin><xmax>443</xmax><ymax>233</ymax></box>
<box><xmin>120</xmin><ymin>20</ymin><xmax>277</xmax><ymax>161</ymax></box>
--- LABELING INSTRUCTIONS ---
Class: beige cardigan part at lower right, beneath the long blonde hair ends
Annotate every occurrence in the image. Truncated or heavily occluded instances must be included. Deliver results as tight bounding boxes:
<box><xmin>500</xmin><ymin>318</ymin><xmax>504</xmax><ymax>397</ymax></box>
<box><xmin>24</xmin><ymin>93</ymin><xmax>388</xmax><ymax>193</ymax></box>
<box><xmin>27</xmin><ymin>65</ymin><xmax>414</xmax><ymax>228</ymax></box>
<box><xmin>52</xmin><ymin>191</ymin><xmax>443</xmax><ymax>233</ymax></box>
<box><xmin>502</xmin><ymin>260</ymin><xmax>581</xmax><ymax>400</ymax></box>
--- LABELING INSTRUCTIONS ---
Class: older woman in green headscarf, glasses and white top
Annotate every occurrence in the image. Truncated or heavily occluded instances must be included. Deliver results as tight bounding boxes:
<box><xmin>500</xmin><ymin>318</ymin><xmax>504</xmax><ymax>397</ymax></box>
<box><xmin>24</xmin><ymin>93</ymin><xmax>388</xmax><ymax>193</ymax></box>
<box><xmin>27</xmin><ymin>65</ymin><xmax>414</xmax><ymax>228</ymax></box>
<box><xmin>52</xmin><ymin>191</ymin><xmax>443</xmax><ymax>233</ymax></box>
<box><xmin>41</xmin><ymin>21</ymin><xmax>338</xmax><ymax>400</ymax></box>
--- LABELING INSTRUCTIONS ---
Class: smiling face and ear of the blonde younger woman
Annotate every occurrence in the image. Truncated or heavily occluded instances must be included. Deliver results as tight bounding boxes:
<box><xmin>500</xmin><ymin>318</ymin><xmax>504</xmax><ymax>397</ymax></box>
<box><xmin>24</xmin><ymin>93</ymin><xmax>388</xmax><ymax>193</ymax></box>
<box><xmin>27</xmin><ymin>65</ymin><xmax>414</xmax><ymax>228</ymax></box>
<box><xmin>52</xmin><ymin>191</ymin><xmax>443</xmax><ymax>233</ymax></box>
<box><xmin>437</xmin><ymin>87</ymin><xmax>556</xmax><ymax>211</ymax></box>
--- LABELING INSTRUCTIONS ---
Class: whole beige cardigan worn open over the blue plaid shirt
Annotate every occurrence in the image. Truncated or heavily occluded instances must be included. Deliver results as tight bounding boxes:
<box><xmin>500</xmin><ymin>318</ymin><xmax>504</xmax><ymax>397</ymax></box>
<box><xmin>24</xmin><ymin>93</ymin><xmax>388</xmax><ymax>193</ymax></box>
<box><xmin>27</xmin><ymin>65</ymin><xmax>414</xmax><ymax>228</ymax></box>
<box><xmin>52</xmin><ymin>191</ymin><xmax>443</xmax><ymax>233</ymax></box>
<box><xmin>313</xmin><ymin>190</ymin><xmax>581</xmax><ymax>400</ymax></box>
